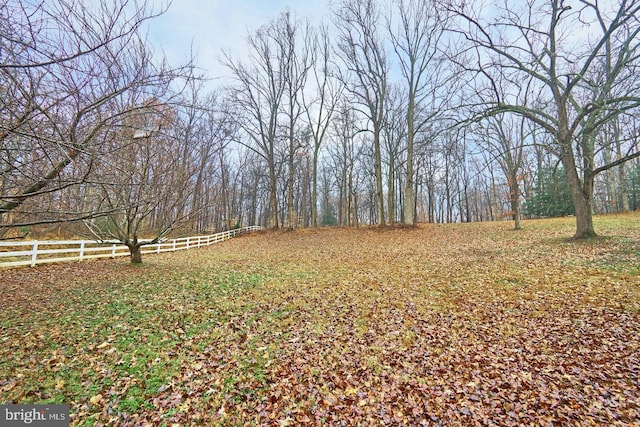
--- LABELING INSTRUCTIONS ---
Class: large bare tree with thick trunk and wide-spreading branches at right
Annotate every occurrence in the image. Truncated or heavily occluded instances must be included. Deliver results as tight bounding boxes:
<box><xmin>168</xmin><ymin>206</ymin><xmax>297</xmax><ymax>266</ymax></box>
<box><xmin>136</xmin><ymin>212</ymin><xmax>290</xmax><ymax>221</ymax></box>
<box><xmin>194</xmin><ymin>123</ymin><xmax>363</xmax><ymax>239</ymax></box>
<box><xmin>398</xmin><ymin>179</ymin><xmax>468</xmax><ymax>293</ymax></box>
<box><xmin>448</xmin><ymin>0</ymin><xmax>640</xmax><ymax>238</ymax></box>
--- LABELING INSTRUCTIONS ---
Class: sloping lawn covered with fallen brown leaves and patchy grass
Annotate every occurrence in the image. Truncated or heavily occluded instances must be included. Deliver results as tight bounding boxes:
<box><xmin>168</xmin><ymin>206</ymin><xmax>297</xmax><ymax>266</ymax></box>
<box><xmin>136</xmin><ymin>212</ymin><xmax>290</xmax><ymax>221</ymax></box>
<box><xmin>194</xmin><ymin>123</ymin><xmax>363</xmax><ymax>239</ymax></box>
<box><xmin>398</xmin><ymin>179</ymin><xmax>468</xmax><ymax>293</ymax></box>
<box><xmin>0</xmin><ymin>214</ymin><xmax>640</xmax><ymax>426</ymax></box>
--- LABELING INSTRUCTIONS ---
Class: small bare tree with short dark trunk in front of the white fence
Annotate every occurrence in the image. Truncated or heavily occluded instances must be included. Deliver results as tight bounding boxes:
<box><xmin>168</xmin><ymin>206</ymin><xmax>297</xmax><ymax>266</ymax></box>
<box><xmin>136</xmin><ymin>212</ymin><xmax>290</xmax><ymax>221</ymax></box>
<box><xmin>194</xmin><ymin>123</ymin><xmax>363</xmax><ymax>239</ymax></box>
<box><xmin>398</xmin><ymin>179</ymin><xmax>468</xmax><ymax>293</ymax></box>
<box><xmin>85</xmin><ymin>99</ymin><xmax>197</xmax><ymax>263</ymax></box>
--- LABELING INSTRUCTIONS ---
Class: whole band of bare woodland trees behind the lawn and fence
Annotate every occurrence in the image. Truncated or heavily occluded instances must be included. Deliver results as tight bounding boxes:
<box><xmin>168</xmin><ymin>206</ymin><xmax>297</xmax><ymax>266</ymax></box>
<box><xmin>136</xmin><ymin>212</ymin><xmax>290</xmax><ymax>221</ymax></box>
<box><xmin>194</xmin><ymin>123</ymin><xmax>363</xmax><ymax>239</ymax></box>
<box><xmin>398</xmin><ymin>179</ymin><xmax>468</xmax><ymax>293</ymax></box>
<box><xmin>0</xmin><ymin>0</ymin><xmax>640</xmax><ymax>253</ymax></box>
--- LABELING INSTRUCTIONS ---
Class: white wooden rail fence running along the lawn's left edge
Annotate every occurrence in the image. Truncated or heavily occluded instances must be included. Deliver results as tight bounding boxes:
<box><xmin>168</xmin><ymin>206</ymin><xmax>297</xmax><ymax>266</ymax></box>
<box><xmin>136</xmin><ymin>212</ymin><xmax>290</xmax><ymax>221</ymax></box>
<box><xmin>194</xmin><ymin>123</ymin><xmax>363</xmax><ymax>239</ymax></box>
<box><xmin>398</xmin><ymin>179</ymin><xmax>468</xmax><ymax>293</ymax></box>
<box><xmin>0</xmin><ymin>225</ymin><xmax>263</xmax><ymax>268</ymax></box>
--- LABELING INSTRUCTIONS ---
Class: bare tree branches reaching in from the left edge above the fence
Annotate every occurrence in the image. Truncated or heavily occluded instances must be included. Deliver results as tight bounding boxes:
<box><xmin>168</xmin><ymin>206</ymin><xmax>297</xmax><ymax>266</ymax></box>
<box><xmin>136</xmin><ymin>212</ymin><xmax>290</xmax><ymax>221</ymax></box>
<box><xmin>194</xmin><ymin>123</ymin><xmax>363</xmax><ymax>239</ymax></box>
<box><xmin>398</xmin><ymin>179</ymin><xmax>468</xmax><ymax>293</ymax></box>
<box><xmin>0</xmin><ymin>0</ymin><xmax>191</xmax><ymax>224</ymax></box>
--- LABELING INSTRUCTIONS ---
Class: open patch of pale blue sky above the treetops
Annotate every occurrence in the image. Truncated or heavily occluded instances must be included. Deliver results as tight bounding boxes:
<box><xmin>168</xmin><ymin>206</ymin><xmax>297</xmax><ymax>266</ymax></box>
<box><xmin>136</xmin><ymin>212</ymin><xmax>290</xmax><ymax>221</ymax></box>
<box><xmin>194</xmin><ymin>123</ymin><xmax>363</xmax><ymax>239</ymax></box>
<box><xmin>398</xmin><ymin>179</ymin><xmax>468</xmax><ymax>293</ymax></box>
<box><xmin>148</xmin><ymin>0</ymin><xmax>330</xmax><ymax>85</ymax></box>
